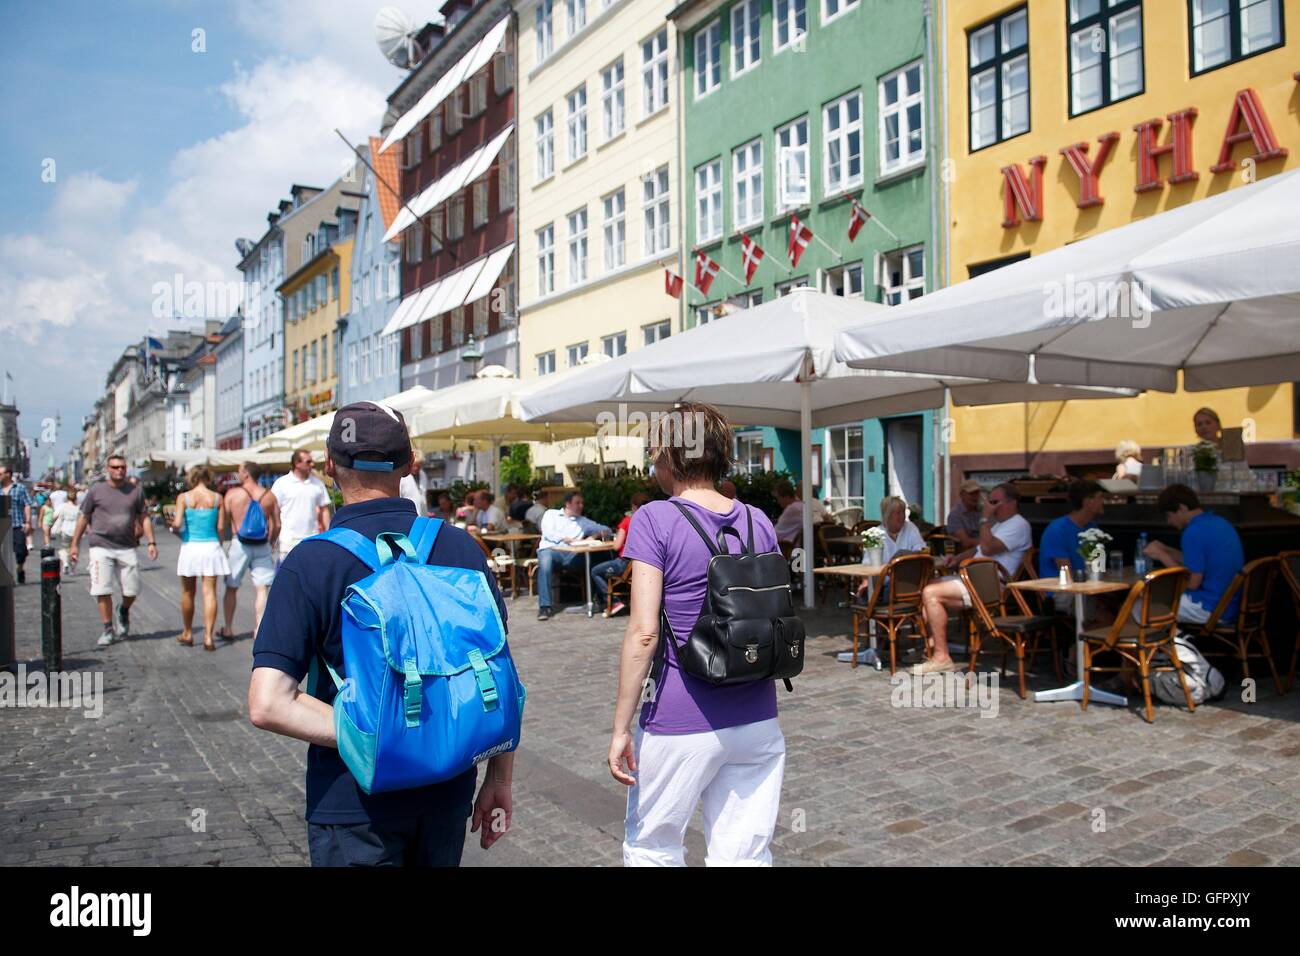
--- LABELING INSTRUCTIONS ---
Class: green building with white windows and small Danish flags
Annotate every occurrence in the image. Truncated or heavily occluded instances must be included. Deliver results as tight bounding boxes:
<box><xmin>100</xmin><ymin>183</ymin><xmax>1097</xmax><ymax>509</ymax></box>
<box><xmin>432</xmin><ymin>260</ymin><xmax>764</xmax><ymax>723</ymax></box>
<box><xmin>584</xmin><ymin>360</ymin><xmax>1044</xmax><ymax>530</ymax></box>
<box><xmin>668</xmin><ymin>0</ymin><xmax>943</xmax><ymax>520</ymax></box>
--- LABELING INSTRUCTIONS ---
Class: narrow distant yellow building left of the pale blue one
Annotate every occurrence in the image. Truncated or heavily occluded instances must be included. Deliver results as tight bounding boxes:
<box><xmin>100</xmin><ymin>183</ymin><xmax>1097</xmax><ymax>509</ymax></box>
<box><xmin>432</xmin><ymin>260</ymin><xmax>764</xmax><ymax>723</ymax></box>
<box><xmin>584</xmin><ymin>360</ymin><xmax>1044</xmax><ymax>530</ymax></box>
<box><xmin>278</xmin><ymin>214</ymin><xmax>356</xmax><ymax>421</ymax></box>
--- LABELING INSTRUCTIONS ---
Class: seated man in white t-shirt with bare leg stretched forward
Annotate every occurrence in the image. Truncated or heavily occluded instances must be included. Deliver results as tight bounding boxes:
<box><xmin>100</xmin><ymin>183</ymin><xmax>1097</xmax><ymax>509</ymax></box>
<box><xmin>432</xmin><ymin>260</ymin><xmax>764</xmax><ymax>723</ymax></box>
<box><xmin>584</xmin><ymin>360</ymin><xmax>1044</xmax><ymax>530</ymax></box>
<box><xmin>913</xmin><ymin>483</ymin><xmax>1034</xmax><ymax>674</ymax></box>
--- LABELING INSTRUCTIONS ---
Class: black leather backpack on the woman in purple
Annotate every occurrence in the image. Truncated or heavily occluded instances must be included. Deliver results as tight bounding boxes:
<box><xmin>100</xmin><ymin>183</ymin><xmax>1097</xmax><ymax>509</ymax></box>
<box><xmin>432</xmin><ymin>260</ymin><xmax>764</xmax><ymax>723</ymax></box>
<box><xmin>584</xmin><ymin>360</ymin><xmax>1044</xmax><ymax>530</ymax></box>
<box><xmin>650</xmin><ymin>501</ymin><xmax>803</xmax><ymax>691</ymax></box>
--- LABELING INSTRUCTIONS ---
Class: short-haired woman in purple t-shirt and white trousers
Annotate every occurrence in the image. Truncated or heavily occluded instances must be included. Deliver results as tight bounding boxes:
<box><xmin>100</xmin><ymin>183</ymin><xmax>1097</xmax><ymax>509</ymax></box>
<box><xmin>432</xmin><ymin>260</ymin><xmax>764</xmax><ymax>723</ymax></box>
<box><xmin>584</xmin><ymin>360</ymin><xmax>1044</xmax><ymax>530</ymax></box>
<box><xmin>608</xmin><ymin>403</ymin><xmax>785</xmax><ymax>866</ymax></box>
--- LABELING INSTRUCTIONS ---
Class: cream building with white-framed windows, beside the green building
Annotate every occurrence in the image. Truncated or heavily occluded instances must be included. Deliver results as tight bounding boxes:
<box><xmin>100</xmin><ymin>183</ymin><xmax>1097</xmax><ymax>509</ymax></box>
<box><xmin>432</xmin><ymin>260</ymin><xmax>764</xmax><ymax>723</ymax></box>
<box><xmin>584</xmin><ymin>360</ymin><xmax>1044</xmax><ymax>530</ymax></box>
<box><xmin>515</xmin><ymin>0</ymin><xmax>683</xmax><ymax>481</ymax></box>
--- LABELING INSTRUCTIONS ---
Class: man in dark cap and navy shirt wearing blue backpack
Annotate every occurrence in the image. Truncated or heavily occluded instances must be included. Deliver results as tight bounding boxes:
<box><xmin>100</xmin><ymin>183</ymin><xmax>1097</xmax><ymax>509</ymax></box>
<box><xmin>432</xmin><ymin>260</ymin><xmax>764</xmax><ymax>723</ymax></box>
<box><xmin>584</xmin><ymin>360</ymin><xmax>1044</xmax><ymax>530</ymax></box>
<box><xmin>248</xmin><ymin>402</ymin><xmax>515</xmax><ymax>866</ymax></box>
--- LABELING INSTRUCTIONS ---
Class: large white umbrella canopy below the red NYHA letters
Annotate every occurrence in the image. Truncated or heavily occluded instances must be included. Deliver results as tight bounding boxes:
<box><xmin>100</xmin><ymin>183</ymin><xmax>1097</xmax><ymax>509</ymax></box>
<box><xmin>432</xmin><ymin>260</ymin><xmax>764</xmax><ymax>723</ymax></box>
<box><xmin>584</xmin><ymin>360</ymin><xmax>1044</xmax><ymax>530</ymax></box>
<box><xmin>836</xmin><ymin>170</ymin><xmax>1300</xmax><ymax>392</ymax></box>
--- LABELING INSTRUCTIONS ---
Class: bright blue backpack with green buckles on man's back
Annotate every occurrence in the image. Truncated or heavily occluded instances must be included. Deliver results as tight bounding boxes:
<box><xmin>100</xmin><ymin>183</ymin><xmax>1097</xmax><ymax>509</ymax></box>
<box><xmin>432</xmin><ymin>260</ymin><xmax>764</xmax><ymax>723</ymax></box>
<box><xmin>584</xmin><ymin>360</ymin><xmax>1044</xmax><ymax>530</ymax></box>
<box><xmin>316</xmin><ymin>518</ymin><xmax>524</xmax><ymax>793</ymax></box>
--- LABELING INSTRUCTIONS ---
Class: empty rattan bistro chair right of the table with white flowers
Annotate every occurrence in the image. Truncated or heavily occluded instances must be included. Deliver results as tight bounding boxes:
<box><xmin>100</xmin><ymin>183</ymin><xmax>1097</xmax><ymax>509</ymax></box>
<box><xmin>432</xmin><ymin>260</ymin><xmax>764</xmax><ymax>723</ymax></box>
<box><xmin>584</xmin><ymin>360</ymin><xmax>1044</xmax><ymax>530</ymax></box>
<box><xmin>1080</xmin><ymin>567</ymin><xmax>1196</xmax><ymax>723</ymax></box>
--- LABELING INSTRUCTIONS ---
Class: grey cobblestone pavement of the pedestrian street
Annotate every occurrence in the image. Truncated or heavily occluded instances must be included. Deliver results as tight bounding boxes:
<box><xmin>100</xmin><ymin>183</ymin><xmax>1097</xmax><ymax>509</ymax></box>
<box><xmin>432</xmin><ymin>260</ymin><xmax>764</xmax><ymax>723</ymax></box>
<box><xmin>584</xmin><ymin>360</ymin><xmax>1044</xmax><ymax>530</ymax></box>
<box><xmin>0</xmin><ymin>532</ymin><xmax>1300</xmax><ymax>866</ymax></box>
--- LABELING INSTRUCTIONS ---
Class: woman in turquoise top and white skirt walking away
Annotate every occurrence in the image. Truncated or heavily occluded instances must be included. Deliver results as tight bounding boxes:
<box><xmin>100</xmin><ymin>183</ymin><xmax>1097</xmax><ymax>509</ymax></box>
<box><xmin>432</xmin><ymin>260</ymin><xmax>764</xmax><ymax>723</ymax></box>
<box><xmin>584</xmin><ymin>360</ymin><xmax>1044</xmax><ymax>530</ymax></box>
<box><xmin>172</xmin><ymin>464</ymin><xmax>230</xmax><ymax>650</ymax></box>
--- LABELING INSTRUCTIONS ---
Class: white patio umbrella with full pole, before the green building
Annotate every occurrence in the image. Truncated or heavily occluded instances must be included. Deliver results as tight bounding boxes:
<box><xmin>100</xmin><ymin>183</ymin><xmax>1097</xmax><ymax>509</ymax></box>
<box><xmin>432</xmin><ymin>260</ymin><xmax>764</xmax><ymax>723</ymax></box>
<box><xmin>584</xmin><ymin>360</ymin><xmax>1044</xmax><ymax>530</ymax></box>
<box><xmin>519</xmin><ymin>289</ymin><xmax>1132</xmax><ymax>607</ymax></box>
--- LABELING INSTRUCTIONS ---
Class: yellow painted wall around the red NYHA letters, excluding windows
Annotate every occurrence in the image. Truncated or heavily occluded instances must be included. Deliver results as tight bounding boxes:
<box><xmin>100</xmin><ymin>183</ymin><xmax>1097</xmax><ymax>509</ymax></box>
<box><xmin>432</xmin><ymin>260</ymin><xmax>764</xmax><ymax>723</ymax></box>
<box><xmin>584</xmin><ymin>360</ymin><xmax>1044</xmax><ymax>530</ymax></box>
<box><xmin>944</xmin><ymin>0</ymin><xmax>1300</xmax><ymax>454</ymax></box>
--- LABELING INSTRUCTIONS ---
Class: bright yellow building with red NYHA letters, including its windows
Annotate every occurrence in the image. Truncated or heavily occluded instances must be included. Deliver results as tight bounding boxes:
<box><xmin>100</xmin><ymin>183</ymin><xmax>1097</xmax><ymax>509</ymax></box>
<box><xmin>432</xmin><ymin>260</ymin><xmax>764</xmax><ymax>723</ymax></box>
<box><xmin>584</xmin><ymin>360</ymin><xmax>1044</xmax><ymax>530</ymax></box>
<box><xmin>937</xmin><ymin>0</ymin><xmax>1300</xmax><ymax>475</ymax></box>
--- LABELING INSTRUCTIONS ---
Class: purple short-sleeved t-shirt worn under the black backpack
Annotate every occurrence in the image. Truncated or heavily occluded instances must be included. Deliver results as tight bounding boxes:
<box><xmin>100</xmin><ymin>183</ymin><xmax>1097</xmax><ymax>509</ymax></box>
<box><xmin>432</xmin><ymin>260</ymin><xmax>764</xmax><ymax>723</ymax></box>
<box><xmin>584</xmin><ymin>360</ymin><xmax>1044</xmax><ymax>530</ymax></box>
<box><xmin>623</xmin><ymin>498</ymin><xmax>777</xmax><ymax>734</ymax></box>
